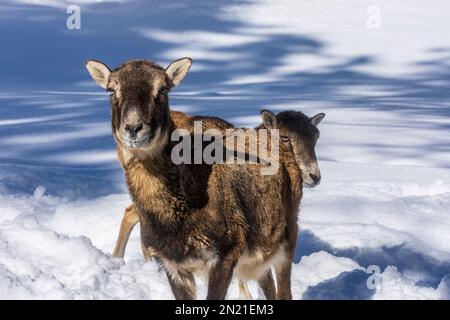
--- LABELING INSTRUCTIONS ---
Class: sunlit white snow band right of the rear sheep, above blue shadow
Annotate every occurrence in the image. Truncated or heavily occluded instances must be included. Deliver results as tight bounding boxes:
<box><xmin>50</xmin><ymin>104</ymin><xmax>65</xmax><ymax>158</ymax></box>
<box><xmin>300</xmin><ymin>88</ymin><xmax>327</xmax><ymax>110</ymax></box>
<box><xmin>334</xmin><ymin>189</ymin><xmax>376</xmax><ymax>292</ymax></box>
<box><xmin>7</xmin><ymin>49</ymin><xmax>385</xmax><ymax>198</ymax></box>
<box><xmin>300</xmin><ymin>162</ymin><xmax>450</xmax><ymax>261</ymax></box>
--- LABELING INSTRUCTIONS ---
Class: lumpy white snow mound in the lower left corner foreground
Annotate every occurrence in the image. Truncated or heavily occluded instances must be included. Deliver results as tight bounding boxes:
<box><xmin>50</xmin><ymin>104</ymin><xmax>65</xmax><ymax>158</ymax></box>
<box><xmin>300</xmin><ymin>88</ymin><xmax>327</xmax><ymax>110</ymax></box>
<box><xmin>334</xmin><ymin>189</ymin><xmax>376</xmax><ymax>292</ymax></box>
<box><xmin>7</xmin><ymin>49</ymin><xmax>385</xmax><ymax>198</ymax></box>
<box><xmin>0</xmin><ymin>194</ymin><xmax>171</xmax><ymax>299</ymax></box>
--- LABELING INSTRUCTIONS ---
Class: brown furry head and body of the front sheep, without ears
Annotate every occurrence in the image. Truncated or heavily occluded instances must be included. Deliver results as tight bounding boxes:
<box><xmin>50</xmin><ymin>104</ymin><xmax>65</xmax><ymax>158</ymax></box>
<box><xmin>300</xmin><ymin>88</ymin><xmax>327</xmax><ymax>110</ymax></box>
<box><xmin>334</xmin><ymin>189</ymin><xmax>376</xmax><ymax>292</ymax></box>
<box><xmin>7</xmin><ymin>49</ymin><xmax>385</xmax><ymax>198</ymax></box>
<box><xmin>86</xmin><ymin>61</ymin><xmax>308</xmax><ymax>299</ymax></box>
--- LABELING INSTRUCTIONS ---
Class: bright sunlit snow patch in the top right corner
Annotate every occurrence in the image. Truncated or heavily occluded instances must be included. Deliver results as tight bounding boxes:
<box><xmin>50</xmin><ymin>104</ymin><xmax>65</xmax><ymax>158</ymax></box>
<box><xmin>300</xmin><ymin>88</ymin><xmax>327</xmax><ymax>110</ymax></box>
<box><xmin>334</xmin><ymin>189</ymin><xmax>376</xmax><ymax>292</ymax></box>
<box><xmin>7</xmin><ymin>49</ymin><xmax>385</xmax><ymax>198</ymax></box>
<box><xmin>224</xmin><ymin>0</ymin><xmax>448</xmax><ymax>75</ymax></box>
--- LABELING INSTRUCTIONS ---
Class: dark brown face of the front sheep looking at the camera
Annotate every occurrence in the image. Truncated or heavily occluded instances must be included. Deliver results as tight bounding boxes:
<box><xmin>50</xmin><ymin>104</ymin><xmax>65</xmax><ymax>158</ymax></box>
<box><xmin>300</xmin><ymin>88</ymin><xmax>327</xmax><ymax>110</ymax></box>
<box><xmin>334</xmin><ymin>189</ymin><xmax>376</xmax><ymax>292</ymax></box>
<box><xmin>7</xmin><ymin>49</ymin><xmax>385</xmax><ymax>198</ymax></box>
<box><xmin>107</xmin><ymin>60</ymin><xmax>170</xmax><ymax>148</ymax></box>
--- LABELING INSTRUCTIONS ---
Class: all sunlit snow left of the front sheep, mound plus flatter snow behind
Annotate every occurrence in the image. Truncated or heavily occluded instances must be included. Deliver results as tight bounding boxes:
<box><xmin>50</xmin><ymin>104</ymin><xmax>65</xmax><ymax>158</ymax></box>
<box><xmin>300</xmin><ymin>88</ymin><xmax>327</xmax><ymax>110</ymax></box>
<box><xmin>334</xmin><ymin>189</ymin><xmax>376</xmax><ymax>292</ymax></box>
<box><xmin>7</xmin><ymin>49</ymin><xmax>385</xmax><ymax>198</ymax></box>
<box><xmin>0</xmin><ymin>192</ymin><xmax>171</xmax><ymax>299</ymax></box>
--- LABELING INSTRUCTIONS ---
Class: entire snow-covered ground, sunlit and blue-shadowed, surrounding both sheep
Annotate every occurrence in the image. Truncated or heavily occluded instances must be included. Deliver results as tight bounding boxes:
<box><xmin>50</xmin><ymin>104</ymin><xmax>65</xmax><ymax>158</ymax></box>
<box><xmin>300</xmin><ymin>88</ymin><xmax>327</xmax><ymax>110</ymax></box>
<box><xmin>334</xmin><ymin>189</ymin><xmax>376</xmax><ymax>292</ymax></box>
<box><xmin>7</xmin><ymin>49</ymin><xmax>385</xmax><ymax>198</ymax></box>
<box><xmin>0</xmin><ymin>0</ymin><xmax>450</xmax><ymax>299</ymax></box>
